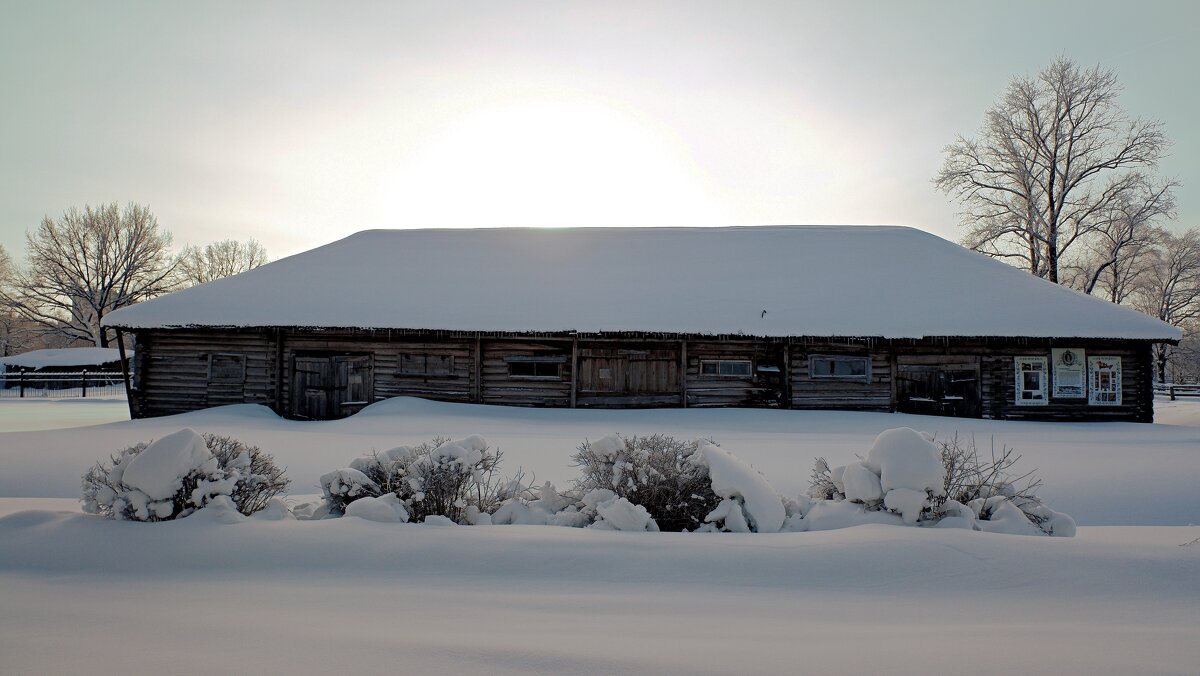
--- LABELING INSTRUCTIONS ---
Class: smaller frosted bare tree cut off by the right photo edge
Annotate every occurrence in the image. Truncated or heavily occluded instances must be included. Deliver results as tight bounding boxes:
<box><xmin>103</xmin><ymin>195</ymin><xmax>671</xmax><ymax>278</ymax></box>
<box><xmin>1135</xmin><ymin>228</ymin><xmax>1200</xmax><ymax>383</ymax></box>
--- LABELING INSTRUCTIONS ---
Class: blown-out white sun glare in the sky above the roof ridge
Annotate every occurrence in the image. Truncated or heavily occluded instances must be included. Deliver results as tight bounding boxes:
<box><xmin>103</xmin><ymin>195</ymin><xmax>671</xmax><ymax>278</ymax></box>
<box><xmin>369</xmin><ymin>103</ymin><xmax>727</xmax><ymax>227</ymax></box>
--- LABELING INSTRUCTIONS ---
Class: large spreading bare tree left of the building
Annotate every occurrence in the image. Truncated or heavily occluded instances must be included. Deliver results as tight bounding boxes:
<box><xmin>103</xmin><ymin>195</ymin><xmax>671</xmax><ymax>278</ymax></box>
<box><xmin>5</xmin><ymin>202</ymin><xmax>174</xmax><ymax>347</ymax></box>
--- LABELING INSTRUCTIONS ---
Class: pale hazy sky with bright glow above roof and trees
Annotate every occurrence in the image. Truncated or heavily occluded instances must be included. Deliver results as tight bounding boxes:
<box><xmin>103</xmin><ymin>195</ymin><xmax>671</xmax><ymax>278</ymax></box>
<box><xmin>0</xmin><ymin>0</ymin><xmax>1200</xmax><ymax>257</ymax></box>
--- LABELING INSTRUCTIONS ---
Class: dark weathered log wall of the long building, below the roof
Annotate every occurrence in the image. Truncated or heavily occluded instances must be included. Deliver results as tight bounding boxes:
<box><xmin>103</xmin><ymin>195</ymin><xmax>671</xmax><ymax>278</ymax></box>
<box><xmin>131</xmin><ymin>329</ymin><xmax>1153</xmax><ymax>421</ymax></box>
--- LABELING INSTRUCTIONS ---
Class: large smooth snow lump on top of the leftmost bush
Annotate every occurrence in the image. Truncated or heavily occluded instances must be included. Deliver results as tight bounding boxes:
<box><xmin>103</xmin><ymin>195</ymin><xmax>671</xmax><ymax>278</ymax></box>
<box><xmin>121</xmin><ymin>427</ymin><xmax>217</xmax><ymax>501</ymax></box>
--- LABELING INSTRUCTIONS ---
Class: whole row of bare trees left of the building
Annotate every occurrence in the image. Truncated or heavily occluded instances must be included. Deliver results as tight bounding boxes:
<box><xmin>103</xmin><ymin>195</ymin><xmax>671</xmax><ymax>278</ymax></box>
<box><xmin>0</xmin><ymin>202</ymin><xmax>268</xmax><ymax>355</ymax></box>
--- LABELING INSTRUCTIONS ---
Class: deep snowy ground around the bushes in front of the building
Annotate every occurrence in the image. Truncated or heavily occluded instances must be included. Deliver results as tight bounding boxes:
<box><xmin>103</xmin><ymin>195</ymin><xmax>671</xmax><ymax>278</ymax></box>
<box><xmin>0</xmin><ymin>400</ymin><xmax>1200</xmax><ymax>675</ymax></box>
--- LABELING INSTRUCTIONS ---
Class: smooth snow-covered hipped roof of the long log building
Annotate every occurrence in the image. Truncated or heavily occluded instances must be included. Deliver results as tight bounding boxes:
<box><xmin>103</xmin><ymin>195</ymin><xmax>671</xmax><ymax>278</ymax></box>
<box><xmin>104</xmin><ymin>226</ymin><xmax>1180</xmax><ymax>340</ymax></box>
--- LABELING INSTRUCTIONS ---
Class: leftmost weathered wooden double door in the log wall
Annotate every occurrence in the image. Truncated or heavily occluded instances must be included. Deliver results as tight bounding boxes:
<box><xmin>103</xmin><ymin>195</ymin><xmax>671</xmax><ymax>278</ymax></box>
<box><xmin>292</xmin><ymin>354</ymin><xmax>374</xmax><ymax>420</ymax></box>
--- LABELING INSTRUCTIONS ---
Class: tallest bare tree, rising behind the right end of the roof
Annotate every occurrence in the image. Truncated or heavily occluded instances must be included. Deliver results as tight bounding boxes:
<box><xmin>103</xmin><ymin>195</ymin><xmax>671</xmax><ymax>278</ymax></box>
<box><xmin>934</xmin><ymin>58</ymin><xmax>1174</xmax><ymax>283</ymax></box>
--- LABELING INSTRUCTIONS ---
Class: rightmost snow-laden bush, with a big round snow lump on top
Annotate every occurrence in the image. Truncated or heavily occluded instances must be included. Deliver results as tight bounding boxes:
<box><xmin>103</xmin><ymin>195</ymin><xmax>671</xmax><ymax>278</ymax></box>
<box><xmin>811</xmin><ymin>427</ymin><xmax>1075</xmax><ymax>537</ymax></box>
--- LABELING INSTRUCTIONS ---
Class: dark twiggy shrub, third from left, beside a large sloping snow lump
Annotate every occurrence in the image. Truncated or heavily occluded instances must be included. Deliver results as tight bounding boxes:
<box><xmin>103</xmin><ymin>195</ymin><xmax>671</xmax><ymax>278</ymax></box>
<box><xmin>572</xmin><ymin>435</ymin><xmax>721</xmax><ymax>531</ymax></box>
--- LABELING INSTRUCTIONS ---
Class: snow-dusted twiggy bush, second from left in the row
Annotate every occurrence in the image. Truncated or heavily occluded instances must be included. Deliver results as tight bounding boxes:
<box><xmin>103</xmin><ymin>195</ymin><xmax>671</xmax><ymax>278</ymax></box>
<box><xmin>320</xmin><ymin>436</ymin><xmax>524</xmax><ymax>524</ymax></box>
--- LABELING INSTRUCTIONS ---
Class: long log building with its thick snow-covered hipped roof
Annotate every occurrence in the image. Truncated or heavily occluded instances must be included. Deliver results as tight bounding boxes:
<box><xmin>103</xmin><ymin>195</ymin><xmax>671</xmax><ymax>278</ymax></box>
<box><xmin>107</xmin><ymin>226</ymin><xmax>1180</xmax><ymax>421</ymax></box>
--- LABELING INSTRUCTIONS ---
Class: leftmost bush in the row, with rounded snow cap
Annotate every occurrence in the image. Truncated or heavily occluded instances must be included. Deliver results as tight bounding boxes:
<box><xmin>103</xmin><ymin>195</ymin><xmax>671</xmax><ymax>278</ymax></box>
<box><xmin>80</xmin><ymin>429</ymin><xmax>289</xmax><ymax>521</ymax></box>
